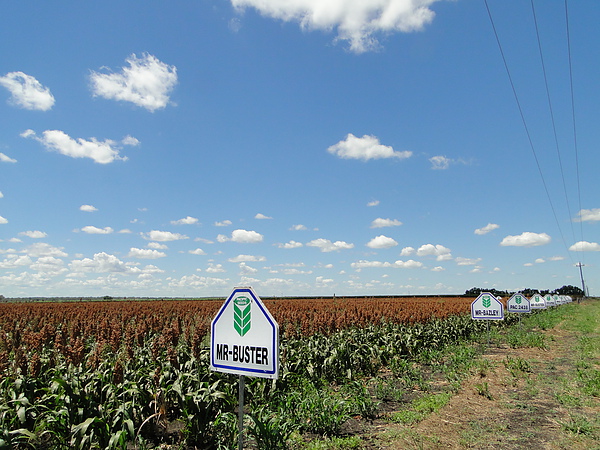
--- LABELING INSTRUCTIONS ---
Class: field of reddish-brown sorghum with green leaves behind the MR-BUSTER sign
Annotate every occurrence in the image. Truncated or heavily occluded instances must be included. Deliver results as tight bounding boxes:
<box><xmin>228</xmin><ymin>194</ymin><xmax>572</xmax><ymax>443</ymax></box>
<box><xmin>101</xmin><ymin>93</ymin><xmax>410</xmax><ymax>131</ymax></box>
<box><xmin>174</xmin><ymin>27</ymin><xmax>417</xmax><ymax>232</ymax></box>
<box><xmin>0</xmin><ymin>297</ymin><xmax>544</xmax><ymax>449</ymax></box>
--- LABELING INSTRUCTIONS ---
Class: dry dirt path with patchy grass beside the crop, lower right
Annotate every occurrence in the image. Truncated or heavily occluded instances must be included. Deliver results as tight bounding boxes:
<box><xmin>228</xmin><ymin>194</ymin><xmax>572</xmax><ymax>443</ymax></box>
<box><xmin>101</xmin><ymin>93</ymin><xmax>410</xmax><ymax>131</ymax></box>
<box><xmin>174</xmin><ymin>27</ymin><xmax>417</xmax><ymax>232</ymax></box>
<box><xmin>368</xmin><ymin>316</ymin><xmax>600</xmax><ymax>450</ymax></box>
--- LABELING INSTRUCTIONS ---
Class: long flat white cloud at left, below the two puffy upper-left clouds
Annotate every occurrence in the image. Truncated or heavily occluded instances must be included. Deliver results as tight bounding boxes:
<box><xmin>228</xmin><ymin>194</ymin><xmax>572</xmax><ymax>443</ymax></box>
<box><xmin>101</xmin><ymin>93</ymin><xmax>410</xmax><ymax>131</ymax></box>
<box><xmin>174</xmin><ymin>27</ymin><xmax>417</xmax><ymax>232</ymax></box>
<box><xmin>21</xmin><ymin>130</ymin><xmax>136</xmax><ymax>164</ymax></box>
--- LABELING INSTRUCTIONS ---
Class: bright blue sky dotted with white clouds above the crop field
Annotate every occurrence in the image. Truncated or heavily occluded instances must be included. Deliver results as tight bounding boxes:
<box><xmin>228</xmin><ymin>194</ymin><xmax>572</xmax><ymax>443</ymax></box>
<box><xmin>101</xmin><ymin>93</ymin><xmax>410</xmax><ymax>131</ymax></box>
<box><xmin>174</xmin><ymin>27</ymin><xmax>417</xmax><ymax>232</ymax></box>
<box><xmin>0</xmin><ymin>0</ymin><xmax>600</xmax><ymax>297</ymax></box>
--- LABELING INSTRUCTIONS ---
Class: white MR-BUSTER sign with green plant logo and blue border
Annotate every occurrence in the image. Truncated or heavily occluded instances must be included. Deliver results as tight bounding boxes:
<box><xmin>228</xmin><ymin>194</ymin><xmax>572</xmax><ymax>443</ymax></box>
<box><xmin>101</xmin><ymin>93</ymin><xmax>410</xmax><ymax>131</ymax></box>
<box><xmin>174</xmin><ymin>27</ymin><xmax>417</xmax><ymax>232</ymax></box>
<box><xmin>210</xmin><ymin>287</ymin><xmax>279</xmax><ymax>379</ymax></box>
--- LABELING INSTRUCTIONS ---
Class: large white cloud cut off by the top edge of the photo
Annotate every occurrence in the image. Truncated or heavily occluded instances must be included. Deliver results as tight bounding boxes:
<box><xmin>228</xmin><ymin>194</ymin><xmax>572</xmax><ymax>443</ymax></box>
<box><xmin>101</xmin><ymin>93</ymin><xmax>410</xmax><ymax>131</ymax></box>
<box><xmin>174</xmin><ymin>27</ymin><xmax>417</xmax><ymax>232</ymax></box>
<box><xmin>231</xmin><ymin>0</ymin><xmax>436</xmax><ymax>53</ymax></box>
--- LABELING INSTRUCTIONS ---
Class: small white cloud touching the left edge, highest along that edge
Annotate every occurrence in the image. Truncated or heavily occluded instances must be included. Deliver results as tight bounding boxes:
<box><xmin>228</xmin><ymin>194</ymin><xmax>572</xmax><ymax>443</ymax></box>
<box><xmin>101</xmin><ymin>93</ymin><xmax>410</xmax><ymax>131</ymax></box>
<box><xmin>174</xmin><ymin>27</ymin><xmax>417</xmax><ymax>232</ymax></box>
<box><xmin>0</xmin><ymin>72</ymin><xmax>54</xmax><ymax>111</ymax></box>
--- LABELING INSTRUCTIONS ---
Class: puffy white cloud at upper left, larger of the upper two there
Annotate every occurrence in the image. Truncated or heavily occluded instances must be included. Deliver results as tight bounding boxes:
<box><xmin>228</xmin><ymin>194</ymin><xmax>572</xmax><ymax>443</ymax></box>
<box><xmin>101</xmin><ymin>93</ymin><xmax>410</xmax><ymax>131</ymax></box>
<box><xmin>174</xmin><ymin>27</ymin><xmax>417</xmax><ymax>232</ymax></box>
<box><xmin>90</xmin><ymin>53</ymin><xmax>177</xmax><ymax>112</ymax></box>
